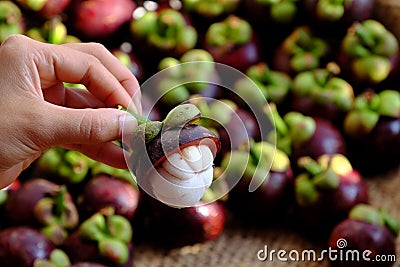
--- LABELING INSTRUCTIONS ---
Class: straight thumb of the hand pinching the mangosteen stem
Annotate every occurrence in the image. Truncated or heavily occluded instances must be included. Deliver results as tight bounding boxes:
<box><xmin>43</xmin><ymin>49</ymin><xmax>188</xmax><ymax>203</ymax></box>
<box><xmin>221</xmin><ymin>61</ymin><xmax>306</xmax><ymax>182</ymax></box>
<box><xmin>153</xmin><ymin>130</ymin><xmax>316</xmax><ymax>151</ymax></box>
<box><xmin>41</xmin><ymin>106</ymin><xmax>137</xmax><ymax>146</ymax></box>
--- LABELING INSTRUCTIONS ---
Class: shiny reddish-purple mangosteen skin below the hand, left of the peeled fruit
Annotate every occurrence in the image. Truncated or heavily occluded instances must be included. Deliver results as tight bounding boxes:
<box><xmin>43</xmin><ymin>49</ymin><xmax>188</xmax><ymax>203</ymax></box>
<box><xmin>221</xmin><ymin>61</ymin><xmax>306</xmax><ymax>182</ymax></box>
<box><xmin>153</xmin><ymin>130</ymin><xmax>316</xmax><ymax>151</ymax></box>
<box><xmin>78</xmin><ymin>174</ymin><xmax>139</xmax><ymax>220</ymax></box>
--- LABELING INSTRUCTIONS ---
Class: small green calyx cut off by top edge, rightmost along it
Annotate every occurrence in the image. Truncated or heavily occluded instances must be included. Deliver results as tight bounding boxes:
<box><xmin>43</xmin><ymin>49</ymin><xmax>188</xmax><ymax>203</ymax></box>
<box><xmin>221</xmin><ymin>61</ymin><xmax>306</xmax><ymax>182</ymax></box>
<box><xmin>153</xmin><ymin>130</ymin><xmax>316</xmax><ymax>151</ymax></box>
<box><xmin>316</xmin><ymin>0</ymin><xmax>351</xmax><ymax>22</ymax></box>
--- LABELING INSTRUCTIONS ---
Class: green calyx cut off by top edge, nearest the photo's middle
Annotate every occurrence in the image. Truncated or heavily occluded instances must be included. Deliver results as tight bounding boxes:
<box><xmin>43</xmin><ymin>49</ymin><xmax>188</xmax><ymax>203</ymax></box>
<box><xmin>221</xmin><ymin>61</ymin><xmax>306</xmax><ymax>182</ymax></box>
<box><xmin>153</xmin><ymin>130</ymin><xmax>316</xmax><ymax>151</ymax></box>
<box><xmin>183</xmin><ymin>0</ymin><xmax>240</xmax><ymax>18</ymax></box>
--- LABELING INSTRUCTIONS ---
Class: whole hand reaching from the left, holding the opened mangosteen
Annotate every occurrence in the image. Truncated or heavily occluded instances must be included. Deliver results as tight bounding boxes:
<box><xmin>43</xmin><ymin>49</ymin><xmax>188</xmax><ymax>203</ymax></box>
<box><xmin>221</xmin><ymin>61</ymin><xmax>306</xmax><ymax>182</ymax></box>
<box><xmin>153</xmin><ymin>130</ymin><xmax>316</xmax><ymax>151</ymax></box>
<box><xmin>0</xmin><ymin>35</ymin><xmax>141</xmax><ymax>188</ymax></box>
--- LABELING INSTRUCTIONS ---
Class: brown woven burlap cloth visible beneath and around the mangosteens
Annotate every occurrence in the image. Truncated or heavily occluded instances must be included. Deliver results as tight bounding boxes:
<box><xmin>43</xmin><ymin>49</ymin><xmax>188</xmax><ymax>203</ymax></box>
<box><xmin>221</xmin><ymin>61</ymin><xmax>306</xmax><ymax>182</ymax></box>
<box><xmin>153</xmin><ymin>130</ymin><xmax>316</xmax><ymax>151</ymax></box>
<box><xmin>135</xmin><ymin>0</ymin><xmax>400</xmax><ymax>267</ymax></box>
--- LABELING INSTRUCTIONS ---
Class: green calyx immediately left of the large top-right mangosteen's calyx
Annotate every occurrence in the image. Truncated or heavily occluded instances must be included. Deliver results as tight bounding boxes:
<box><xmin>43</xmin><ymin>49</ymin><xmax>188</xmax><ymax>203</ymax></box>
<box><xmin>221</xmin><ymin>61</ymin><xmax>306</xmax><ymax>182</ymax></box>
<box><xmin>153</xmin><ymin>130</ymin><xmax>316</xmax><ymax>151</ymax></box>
<box><xmin>283</xmin><ymin>26</ymin><xmax>328</xmax><ymax>72</ymax></box>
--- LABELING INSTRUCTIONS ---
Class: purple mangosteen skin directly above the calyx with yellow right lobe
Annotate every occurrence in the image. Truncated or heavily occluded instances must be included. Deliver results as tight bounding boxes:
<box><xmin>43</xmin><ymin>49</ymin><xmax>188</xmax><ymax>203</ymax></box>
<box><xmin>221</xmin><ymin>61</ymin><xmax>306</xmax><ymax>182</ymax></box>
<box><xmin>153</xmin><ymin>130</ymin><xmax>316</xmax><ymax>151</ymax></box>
<box><xmin>291</xmin><ymin>117</ymin><xmax>347</xmax><ymax>165</ymax></box>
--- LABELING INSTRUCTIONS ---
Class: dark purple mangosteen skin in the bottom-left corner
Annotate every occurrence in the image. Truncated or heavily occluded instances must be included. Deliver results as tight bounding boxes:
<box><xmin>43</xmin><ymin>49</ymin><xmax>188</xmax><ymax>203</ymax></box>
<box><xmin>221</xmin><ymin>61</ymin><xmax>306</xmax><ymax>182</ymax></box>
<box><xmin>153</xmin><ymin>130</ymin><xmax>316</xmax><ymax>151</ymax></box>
<box><xmin>0</xmin><ymin>226</ymin><xmax>55</xmax><ymax>267</ymax></box>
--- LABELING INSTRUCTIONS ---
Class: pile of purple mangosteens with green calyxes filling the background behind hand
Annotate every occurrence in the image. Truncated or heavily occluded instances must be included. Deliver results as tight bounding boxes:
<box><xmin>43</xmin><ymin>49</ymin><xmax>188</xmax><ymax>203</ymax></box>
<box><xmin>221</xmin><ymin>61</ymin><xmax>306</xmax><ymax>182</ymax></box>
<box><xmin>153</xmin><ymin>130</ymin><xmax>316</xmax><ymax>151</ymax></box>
<box><xmin>0</xmin><ymin>0</ymin><xmax>400</xmax><ymax>267</ymax></box>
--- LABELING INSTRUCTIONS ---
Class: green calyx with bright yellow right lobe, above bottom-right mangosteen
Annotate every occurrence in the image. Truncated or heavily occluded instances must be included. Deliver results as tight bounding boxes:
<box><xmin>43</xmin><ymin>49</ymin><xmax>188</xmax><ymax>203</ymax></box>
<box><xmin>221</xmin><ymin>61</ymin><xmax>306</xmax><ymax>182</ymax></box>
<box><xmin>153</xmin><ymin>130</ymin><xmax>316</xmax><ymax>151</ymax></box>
<box><xmin>295</xmin><ymin>154</ymin><xmax>353</xmax><ymax>206</ymax></box>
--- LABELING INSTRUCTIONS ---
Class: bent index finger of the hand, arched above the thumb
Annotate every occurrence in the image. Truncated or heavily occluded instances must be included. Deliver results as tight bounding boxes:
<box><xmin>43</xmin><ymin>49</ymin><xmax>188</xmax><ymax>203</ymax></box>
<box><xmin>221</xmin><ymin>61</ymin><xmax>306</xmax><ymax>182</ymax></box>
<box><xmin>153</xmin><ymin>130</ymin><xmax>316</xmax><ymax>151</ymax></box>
<box><xmin>34</xmin><ymin>41</ymin><xmax>140</xmax><ymax>112</ymax></box>
